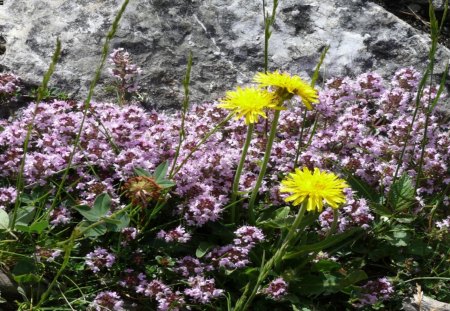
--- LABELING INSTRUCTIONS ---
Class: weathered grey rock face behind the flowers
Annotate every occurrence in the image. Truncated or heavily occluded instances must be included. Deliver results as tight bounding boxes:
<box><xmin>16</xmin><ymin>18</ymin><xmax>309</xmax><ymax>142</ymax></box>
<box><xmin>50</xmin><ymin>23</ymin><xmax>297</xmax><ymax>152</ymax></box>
<box><xmin>0</xmin><ymin>0</ymin><xmax>450</xmax><ymax>108</ymax></box>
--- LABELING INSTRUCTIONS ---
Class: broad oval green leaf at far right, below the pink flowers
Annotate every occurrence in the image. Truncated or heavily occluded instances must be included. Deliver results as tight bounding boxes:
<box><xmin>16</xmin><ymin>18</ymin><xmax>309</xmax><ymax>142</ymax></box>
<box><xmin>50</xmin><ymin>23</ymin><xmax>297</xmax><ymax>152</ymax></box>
<box><xmin>388</xmin><ymin>174</ymin><xmax>414</xmax><ymax>211</ymax></box>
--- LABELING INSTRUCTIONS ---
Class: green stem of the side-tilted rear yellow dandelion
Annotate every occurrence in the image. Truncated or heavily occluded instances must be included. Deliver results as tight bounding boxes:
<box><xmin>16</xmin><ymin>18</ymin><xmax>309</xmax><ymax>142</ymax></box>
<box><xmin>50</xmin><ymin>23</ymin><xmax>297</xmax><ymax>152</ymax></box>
<box><xmin>248</xmin><ymin>109</ymin><xmax>284</xmax><ymax>225</ymax></box>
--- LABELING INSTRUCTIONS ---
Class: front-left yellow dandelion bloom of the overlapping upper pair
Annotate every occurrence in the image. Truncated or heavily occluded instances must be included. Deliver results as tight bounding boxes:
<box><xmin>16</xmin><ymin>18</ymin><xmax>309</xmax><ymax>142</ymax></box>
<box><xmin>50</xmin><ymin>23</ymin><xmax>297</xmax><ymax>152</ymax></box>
<box><xmin>218</xmin><ymin>87</ymin><xmax>280</xmax><ymax>125</ymax></box>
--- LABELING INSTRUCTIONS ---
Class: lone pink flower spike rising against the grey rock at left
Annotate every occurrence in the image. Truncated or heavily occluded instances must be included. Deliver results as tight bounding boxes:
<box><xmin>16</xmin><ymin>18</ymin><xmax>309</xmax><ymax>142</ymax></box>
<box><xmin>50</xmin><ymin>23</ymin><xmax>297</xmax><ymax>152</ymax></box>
<box><xmin>108</xmin><ymin>48</ymin><xmax>142</xmax><ymax>93</ymax></box>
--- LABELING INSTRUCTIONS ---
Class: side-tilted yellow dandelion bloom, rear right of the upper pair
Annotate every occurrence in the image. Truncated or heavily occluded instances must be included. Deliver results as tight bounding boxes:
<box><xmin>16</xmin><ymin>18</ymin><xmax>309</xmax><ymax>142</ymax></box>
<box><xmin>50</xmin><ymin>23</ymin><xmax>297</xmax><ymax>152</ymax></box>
<box><xmin>253</xmin><ymin>71</ymin><xmax>319</xmax><ymax>110</ymax></box>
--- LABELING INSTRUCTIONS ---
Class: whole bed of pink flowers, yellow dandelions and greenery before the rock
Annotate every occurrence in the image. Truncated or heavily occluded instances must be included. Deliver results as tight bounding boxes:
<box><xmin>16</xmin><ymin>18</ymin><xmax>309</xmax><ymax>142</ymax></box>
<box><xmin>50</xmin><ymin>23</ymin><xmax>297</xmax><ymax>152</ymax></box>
<box><xmin>0</xmin><ymin>1</ymin><xmax>450</xmax><ymax>311</ymax></box>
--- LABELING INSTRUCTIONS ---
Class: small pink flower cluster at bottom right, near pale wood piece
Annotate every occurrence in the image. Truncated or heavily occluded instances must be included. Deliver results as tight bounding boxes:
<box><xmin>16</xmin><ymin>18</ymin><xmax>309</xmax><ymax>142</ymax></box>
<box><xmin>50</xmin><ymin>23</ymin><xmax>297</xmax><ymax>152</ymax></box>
<box><xmin>354</xmin><ymin>278</ymin><xmax>394</xmax><ymax>308</ymax></box>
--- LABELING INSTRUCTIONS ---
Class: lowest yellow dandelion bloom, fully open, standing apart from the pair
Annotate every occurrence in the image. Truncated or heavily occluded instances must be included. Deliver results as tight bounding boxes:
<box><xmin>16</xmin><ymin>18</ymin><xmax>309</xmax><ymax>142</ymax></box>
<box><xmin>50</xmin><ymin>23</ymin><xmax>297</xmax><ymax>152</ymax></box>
<box><xmin>280</xmin><ymin>167</ymin><xmax>348</xmax><ymax>212</ymax></box>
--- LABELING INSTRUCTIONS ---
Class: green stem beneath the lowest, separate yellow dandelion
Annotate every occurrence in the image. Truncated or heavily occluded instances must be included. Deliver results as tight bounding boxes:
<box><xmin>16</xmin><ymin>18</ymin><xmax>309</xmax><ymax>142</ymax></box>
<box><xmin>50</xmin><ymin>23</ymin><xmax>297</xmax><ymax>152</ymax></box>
<box><xmin>234</xmin><ymin>200</ymin><xmax>308</xmax><ymax>311</ymax></box>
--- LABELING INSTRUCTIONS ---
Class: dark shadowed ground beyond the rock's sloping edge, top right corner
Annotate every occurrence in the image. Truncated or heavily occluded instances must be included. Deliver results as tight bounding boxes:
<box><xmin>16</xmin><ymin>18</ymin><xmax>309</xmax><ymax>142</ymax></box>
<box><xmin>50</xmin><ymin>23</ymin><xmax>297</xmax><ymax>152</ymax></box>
<box><xmin>369</xmin><ymin>0</ymin><xmax>450</xmax><ymax>49</ymax></box>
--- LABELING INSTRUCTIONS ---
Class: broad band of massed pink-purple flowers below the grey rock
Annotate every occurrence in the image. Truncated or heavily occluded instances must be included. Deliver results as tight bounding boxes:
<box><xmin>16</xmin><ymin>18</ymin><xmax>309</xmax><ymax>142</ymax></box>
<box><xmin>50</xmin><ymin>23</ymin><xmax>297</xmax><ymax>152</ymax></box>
<box><xmin>0</xmin><ymin>67</ymin><xmax>450</xmax><ymax>230</ymax></box>
